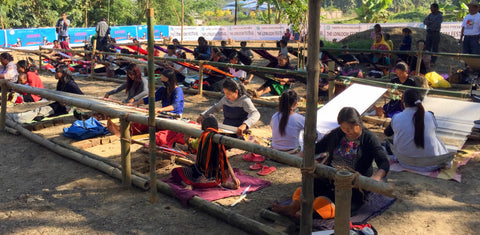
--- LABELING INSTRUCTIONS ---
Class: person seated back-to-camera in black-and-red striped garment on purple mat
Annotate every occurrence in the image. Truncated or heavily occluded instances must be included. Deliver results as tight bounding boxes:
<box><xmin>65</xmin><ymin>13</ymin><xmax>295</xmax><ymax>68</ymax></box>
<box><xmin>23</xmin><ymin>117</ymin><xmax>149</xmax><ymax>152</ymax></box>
<box><xmin>172</xmin><ymin>117</ymin><xmax>240</xmax><ymax>189</ymax></box>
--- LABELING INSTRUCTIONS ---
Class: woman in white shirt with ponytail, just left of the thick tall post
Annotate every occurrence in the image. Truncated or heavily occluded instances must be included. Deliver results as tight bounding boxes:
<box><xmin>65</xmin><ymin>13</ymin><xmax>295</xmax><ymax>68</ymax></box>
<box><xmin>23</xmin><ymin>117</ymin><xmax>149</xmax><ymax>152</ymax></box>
<box><xmin>270</xmin><ymin>89</ymin><xmax>305</xmax><ymax>156</ymax></box>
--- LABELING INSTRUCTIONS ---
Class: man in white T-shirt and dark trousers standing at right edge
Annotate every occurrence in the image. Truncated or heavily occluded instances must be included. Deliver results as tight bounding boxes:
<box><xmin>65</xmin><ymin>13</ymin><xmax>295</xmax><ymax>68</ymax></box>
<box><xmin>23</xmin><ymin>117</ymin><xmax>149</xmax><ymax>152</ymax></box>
<box><xmin>459</xmin><ymin>0</ymin><xmax>480</xmax><ymax>54</ymax></box>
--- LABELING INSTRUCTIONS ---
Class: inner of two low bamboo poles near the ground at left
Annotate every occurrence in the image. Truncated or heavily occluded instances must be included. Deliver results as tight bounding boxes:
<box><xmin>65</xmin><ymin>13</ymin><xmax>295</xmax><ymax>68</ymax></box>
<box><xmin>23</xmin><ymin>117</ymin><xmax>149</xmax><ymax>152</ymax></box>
<box><xmin>6</xmin><ymin>120</ymin><xmax>149</xmax><ymax>190</ymax></box>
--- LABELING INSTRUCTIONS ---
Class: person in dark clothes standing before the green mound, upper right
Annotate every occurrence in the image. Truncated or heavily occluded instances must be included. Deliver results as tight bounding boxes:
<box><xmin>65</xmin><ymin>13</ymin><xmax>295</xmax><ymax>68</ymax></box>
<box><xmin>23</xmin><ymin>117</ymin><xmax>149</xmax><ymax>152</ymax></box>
<box><xmin>423</xmin><ymin>3</ymin><xmax>443</xmax><ymax>63</ymax></box>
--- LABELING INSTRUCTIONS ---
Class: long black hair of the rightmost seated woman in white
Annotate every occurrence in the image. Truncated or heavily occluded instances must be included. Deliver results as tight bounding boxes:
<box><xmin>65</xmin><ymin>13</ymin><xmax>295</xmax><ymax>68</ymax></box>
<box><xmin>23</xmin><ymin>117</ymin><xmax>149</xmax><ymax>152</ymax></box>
<box><xmin>403</xmin><ymin>89</ymin><xmax>425</xmax><ymax>148</ymax></box>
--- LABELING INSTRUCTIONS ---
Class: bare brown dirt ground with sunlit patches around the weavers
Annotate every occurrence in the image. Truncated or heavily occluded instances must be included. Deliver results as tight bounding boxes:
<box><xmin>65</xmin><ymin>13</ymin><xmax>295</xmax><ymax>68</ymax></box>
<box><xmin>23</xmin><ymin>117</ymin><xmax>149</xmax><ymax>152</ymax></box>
<box><xmin>0</xmin><ymin>37</ymin><xmax>480</xmax><ymax>234</ymax></box>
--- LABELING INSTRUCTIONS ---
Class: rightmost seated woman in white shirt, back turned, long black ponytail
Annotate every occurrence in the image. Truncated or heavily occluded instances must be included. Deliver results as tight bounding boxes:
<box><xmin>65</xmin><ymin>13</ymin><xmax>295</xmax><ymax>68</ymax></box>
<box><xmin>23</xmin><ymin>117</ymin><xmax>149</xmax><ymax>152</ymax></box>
<box><xmin>384</xmin><ymin>89</ymin><xmax>454</xmax><ymax>171</ymax></box>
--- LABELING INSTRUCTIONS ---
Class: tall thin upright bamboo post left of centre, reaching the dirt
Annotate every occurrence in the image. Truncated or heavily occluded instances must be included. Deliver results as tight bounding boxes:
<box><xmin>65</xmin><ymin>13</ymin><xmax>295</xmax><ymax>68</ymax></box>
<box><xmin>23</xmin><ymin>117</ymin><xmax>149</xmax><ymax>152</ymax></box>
<box><xmin>147</xmin><ymin>8</ymin><xmax>157</xmax><ymax>203</ymax></box>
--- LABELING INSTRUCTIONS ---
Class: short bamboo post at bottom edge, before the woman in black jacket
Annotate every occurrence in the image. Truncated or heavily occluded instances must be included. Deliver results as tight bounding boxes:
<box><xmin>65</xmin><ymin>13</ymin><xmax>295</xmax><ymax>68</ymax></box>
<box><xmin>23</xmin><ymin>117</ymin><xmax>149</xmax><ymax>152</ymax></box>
<box><xmin>335</xmin><ymin>171</ymin><xmax>353</xmax><ymax>235</ymax></box>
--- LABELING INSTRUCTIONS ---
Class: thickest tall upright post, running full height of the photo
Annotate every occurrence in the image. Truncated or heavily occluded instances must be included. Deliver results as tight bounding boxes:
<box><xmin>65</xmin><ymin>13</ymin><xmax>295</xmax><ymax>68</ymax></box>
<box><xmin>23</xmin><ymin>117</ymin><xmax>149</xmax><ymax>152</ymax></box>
<box><xmin>300</xmin><ymin>0</ymin><xmax>322</xmax><ymax>235</ymax></box>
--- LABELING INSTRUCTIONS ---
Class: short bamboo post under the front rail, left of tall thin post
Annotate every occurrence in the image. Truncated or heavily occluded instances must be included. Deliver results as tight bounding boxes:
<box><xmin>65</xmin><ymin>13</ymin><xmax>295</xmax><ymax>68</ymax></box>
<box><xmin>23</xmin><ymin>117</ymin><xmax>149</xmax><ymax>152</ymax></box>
<box><xmin>120</xmin><ymin>118</ymin><xmax>132</xmax><ymax>187</ymax></box>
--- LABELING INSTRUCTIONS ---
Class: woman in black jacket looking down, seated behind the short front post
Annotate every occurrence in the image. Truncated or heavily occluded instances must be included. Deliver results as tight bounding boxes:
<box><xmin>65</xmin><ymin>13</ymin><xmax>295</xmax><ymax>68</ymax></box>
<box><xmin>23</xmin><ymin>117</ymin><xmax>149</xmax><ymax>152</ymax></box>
<box><xmin>272</xmin><ymin>107</ymin><xmax>390</xmax><ymax>219</ymax></box>
